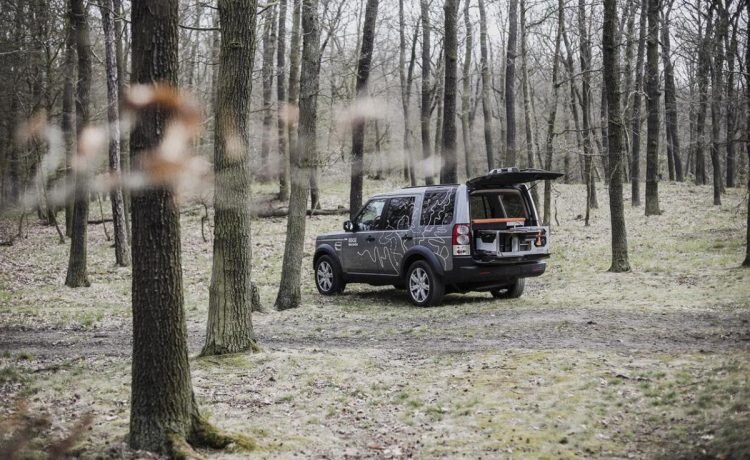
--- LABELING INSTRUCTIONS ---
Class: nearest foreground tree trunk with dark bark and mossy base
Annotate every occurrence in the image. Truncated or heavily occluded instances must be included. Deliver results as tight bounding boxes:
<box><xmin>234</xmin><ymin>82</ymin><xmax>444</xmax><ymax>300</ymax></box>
<box><xmin>129</xmin><ymin>0</ymin><xmax>255</xmax><ymax>452</ymax></box>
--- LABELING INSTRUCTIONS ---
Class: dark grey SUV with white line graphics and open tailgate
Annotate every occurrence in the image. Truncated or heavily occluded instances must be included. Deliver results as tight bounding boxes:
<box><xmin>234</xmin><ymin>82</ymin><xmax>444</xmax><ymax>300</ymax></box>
<box><xmin>313</xmin><ymin>168</ymin><xmax>562</xmax><ymax>306</ymax></box>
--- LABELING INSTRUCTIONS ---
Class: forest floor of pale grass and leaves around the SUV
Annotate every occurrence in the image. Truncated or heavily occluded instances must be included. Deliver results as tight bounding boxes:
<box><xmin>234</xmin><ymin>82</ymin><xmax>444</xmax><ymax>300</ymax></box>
<box><xmin>0</xmin><ymin>181</ymin><xmax>750</xmax><ymax>458</ymax></box>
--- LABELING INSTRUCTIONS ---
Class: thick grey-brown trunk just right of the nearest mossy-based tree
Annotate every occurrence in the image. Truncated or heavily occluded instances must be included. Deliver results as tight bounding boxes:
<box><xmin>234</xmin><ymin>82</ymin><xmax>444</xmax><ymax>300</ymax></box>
<box><xmin>201</xmin><ymin>1</ymin><xmax>256</xmax><ymax>355</ymax></box>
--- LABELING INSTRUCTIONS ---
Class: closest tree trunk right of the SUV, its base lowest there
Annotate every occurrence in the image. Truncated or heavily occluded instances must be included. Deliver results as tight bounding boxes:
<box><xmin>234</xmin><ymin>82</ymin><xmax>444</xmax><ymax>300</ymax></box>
<box><xmin>602</xmin><ymin>0</ymin><xmax>630</xmax><ymax>272</ymax></box>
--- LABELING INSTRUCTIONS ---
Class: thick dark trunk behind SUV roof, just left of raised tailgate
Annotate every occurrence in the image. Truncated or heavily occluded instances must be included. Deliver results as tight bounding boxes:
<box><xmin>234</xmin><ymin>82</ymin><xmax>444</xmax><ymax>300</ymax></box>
<box><xmin>440</xmin><ymin>0</ymin><xmax>458</xmax><ymax>184</ymax></box>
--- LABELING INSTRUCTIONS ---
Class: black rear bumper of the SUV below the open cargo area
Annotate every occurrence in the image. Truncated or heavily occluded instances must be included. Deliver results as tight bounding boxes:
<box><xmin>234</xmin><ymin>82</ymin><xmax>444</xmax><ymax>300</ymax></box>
<box><xmin>445</xmin><ymin>257</ymin><xmax>547</xmax><ymax>289</ymax></box>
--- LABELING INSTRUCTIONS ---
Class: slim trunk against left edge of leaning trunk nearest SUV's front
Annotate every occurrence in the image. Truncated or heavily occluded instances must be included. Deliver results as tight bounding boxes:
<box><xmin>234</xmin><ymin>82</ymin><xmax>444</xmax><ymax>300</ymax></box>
<box><xmin>279</xmin><ymin>0</ymin><xmax>302</xmax><ymax>201</ymax></box>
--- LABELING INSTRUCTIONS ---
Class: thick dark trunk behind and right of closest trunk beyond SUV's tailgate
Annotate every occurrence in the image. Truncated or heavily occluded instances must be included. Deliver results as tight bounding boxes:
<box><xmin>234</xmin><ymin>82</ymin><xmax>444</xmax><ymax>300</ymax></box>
<box><xmin>646</xmin><ymin>0</ymin><xmax>661</xmax><ymax>216</ymax></box>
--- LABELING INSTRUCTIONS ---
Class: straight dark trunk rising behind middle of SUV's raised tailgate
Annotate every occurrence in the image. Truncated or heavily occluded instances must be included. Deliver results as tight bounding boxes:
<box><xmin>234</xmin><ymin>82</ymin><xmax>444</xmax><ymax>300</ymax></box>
<box><xmin>505</xmin><ymin>0</ymin><xmax>518</xmax><ymax>166</ymax></box>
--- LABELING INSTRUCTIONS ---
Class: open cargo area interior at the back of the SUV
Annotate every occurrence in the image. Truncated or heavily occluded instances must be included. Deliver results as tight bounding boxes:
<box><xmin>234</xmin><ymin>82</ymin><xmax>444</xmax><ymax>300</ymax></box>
<box><xmin>469</xmin><ymin>188</ymin><xmax>547</xmax><ymax>260</ymax></box>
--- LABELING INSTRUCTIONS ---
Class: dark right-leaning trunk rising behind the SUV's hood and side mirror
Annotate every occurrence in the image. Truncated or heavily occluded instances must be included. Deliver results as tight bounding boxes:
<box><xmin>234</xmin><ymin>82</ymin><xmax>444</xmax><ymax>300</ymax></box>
<box><xmin>348</xmin><ymin>0</ymin><xmax>379</xmax><ymax>219</ymax></box>
